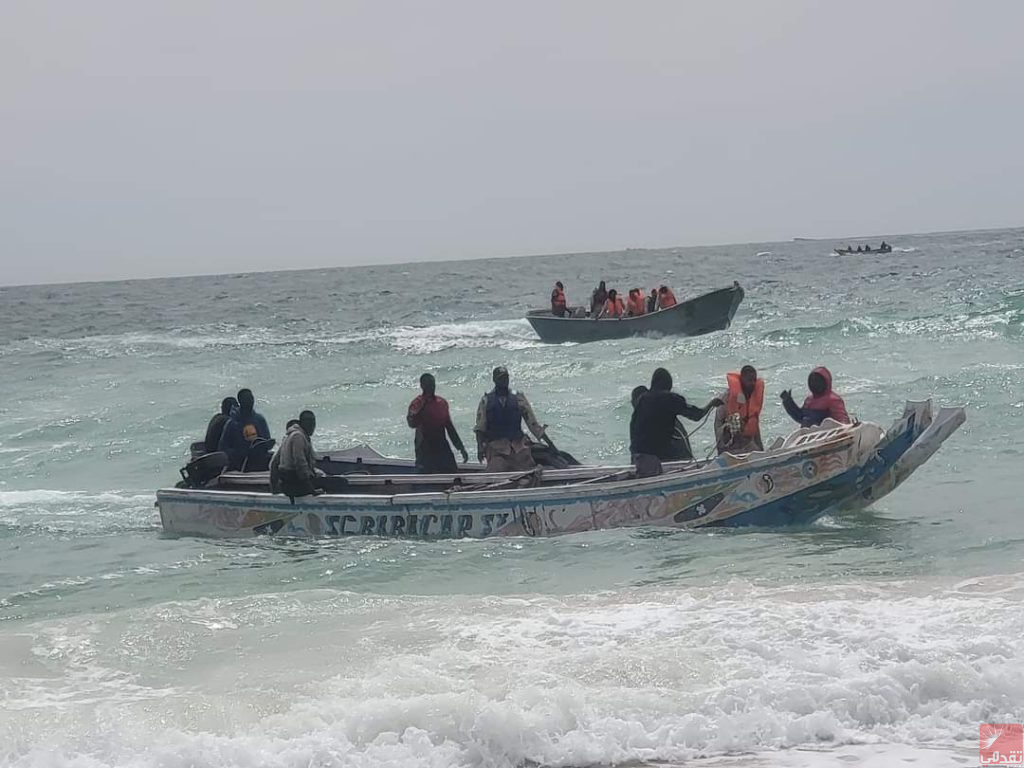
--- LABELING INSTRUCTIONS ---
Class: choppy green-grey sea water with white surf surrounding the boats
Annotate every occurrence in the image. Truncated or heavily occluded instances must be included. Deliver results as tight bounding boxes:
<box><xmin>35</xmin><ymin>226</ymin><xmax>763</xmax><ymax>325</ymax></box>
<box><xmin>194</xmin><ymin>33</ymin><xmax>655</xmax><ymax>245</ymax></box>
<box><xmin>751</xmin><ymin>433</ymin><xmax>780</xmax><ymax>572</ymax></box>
<box><xmin>0</xmin><ymin>229</ymin><xmax>1024</xmax><ymax>768</ymax></box>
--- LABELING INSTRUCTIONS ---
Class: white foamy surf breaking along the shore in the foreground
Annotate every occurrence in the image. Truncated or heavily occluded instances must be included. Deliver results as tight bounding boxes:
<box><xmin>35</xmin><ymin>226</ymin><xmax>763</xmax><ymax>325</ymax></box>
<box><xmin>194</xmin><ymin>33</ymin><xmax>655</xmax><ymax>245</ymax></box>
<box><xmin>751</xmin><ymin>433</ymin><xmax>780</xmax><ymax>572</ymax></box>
<box><xmin>0</xmin><ymin>578</ymin><xmax>1024</xmax><ymax>768</ymax></box>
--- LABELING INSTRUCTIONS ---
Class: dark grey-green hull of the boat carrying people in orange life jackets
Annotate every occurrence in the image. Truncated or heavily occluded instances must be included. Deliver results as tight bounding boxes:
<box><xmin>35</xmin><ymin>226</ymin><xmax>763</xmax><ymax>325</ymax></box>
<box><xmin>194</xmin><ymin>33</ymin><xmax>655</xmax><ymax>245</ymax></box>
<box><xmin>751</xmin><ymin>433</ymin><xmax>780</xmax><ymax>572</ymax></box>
<box><xmin>526</xmin><ymin>283</ymin><xmax>743</xmax><ymax>344</ymax></box>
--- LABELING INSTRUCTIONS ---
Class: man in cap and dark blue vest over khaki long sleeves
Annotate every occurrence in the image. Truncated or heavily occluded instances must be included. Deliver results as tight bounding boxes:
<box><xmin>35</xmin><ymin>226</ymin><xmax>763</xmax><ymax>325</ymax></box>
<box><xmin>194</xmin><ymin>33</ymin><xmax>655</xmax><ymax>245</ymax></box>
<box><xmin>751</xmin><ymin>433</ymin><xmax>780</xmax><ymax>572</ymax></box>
<box><xmin>473</xmin><ymin>366</ymin><xmax>548</xmax><ymax>472</ymax></box>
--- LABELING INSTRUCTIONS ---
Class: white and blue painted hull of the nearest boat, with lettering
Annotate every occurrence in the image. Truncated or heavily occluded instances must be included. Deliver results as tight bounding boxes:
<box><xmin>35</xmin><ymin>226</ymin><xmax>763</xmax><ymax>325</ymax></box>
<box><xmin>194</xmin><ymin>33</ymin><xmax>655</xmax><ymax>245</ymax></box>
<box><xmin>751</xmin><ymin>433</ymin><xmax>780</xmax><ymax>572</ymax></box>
<box><xmin>157</xmin><ymin>401</ymin><xmax>966</xmax><ymax>538</ymax></box>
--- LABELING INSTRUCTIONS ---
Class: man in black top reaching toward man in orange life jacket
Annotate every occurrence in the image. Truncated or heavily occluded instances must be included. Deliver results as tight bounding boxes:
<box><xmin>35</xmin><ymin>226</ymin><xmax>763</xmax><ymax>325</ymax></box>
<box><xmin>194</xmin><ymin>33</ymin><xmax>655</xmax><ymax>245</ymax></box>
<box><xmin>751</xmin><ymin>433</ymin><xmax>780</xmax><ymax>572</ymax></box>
<box><xmin>630</xmin><ymin>368</ymin><xmax>722</xmax><ymax>477</ymax></box>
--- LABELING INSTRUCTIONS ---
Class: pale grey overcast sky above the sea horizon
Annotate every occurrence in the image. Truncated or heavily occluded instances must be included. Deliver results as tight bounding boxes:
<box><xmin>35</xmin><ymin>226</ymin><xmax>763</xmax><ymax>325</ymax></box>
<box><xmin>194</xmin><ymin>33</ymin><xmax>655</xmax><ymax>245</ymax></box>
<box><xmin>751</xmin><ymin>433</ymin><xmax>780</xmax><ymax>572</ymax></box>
<box><xmin>0</xmin><ymin>0</ymin><xmax>1024</xmax><ymax>284</ymax></box>
